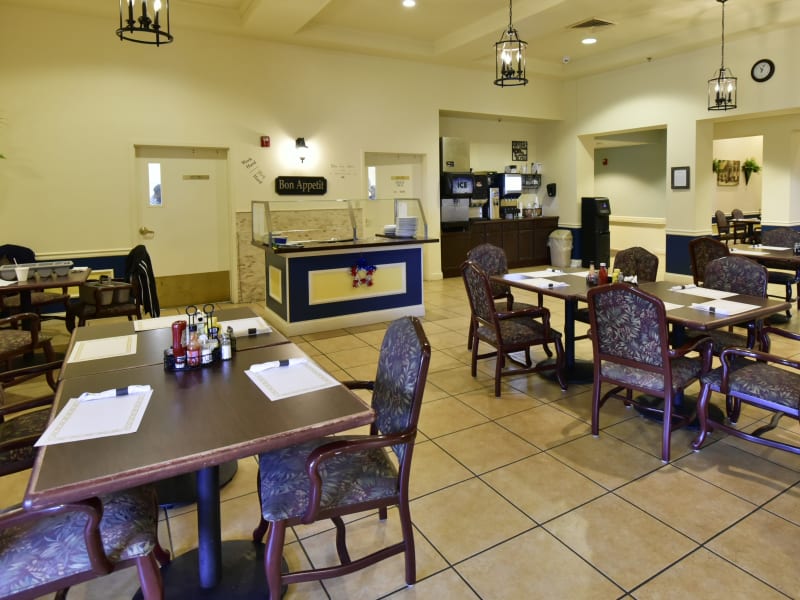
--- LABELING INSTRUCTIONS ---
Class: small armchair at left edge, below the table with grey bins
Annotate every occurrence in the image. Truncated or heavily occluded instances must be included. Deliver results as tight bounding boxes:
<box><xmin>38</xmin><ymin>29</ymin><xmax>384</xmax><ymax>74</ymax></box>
<box><xmin>0</xmin><ymin>313</ymin><xmax>56</xmax><ymax>390</ymax></box>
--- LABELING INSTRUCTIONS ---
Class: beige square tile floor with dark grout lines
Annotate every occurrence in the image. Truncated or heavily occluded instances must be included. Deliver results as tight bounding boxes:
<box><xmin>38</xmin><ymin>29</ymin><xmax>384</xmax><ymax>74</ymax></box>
<box><xmin>2</xmin><ymin>279</ymin><xmax>800</xmax><ymax>600</ymax></box>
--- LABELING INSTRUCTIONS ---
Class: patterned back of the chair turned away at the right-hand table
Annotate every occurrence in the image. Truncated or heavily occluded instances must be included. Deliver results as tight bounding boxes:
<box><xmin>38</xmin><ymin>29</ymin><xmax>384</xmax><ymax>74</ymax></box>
<box><xmin>587</xmin><ymin>283</ymin><xmax>669</xmax><ymax>372</ymax></box>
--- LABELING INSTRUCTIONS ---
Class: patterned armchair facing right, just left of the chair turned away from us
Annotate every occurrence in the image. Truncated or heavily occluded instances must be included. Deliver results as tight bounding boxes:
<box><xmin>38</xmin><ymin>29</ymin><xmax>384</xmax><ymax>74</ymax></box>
<box><xmin>461</xmin><ymin>260</ymin><xmax>567</xmax><ymax>397</ymax></box>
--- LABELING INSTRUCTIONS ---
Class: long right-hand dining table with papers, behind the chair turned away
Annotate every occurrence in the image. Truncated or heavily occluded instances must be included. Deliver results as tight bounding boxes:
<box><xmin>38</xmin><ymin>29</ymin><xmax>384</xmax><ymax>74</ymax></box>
<box><xmin>491</xmin><ymin>267</ymin><xmax>789</xmax><ymax>383</ymax></box>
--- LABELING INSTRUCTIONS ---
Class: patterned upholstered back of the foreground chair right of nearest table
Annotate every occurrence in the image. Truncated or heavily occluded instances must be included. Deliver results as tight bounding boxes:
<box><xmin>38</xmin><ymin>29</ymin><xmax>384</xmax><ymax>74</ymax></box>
<box><xmin>372</xmin><ymin>317</ymin><xmax>431</xmax><ymax>463</ymax></box>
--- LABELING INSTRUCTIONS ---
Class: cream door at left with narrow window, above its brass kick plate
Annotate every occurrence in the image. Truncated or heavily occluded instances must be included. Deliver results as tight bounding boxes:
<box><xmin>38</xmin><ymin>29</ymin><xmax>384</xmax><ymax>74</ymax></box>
<box><xmin>135</xmin><ymin>146</ymin><xmax>230</xmax><ymax>277</ymax></box>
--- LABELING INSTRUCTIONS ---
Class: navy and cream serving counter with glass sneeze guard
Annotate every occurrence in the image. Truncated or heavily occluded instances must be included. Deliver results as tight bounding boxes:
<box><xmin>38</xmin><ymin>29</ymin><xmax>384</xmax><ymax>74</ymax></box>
<box><xmin>251</xmin><ymin>199</ymin><xmax>438</xmax><ymax>336</ymax></box>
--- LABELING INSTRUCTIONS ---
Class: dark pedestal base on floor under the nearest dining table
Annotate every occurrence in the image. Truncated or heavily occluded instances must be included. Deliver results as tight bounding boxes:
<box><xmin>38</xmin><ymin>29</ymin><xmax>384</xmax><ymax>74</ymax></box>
<box><xmin>133</xmin><ymin>540</ymin><xmax>288</xmax><ymax>600</ymax></box>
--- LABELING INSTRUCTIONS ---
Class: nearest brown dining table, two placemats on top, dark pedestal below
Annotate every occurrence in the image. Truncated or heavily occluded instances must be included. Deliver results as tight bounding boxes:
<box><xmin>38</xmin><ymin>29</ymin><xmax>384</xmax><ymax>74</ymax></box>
<box><xmin>23</xmin><ymin>316</ymin><xmax>374</xmax><ymax>599</ymax></box>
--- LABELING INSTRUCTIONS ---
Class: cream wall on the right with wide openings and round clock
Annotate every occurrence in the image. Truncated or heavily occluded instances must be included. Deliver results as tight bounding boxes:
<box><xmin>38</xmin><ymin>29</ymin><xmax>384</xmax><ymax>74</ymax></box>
<box><xmin>549</xmin><ymin>28</ymin><xmax>800</xmax><ymax>235</ymax></box>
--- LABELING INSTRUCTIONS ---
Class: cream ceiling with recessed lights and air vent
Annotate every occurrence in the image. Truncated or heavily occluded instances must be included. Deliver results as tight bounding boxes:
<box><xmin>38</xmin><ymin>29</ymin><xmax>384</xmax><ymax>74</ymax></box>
<box><xmin>6</xmin><ymin>0</ymin><xmax>800</xmax><ymax>78</ymax></box>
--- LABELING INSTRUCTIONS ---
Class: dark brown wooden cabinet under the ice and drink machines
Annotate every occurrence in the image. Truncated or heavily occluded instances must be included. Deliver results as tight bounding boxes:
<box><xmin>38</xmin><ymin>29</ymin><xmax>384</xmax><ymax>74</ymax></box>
<box><xmin>441</xmin><ymin>217</ymin><xmax>558</xmax><ymax>277</ymax></box>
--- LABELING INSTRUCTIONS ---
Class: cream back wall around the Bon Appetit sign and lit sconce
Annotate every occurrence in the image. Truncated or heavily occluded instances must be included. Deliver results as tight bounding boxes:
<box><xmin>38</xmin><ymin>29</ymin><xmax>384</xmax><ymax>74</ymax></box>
<box><xmin>0</xmin><ymin>5</ymin><xmax>561</xmax><ymax>277</ymax></box>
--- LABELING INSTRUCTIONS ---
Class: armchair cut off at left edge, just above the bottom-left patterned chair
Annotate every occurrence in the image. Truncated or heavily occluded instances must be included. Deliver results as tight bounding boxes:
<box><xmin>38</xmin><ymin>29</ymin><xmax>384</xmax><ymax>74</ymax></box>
<box><xmin>0</xmin><ymin>361</ymin><xmax>61</xmax><ymax>476</ymax></box>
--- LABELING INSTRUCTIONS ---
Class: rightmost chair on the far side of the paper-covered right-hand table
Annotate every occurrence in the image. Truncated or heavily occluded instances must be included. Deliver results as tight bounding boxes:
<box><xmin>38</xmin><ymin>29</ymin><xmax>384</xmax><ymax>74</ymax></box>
<box><xmin>687</xmin><ymin>255</ymin><xmax>767</xmax><ymax>356</ymax></box>
